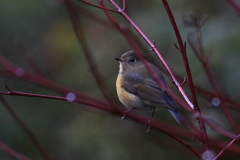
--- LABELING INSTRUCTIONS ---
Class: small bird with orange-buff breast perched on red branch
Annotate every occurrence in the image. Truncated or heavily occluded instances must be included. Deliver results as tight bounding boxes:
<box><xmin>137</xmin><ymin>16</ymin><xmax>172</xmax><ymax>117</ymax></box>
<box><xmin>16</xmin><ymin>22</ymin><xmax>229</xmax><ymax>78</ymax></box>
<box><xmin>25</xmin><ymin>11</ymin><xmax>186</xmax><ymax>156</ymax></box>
<box><xmin>115</xmin><ymin>51</ymin><xmax>186</xmax><ymax>132</ymax></box>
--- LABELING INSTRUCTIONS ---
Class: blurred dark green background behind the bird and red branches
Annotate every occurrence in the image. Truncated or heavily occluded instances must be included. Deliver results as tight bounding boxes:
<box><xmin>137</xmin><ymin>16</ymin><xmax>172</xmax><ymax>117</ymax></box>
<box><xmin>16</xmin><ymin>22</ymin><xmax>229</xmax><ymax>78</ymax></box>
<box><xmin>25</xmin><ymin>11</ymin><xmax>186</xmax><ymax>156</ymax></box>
<box><xmin>0</xmin><ymin>0</ymin><xmax>240</xmax><ymax>160</ymax></box>
